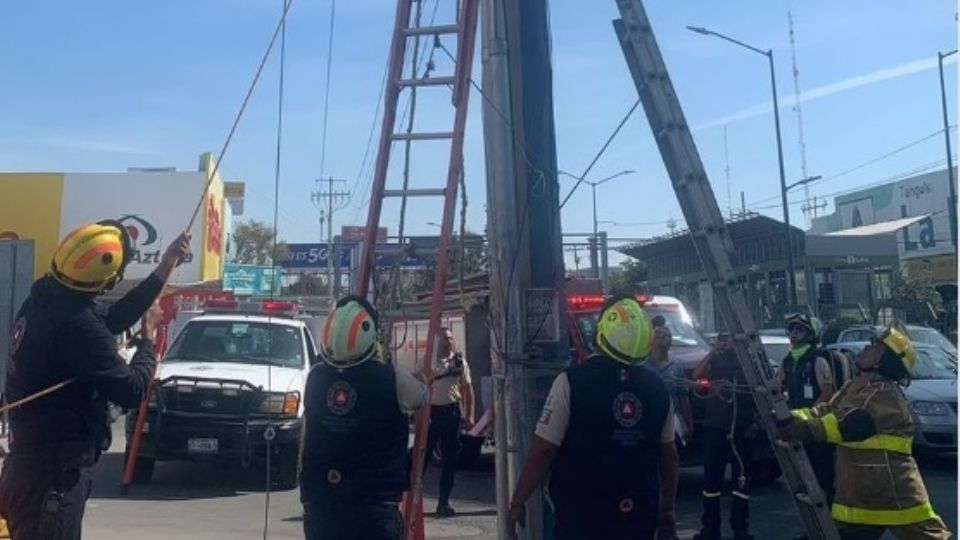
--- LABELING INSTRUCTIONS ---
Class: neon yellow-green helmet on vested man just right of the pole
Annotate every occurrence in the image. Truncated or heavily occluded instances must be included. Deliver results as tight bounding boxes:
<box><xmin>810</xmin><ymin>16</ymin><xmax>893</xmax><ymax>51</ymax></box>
<box><xmin>597</xmin><ymin>296</ymin><xmax>653</xmax><ymax>364</ymax></box>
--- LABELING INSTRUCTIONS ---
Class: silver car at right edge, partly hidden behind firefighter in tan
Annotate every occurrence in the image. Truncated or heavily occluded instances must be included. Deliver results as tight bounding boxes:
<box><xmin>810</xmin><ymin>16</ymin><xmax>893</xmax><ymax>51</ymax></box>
<box><xmin>828</xmin><ymin>341</ymin><xmax>957</xmax><ymax>453</ymax></box>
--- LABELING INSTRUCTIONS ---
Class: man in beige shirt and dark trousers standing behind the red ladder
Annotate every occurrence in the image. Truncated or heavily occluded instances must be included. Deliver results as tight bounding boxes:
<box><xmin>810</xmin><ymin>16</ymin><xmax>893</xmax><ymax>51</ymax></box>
<box><xmin>424</xmin><ymin>328</ymin><xmax>474</xmax><ymax>517</ymax></box>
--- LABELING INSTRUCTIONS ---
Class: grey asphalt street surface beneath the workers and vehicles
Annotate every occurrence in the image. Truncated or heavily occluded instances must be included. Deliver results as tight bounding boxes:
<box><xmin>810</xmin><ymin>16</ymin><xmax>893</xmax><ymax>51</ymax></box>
<box><xmin>73</xmin><ymin>424</ymin><xmax>957</xmax><ymax>540</ymax></box>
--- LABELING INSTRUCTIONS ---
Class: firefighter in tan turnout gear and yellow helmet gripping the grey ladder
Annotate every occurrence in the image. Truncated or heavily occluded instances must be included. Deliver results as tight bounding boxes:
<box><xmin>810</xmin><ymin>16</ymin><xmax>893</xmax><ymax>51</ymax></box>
<box><xmin>780</xmin><ymin>328</ymin><xmax>951</xmax><ymax>540</ymax></box>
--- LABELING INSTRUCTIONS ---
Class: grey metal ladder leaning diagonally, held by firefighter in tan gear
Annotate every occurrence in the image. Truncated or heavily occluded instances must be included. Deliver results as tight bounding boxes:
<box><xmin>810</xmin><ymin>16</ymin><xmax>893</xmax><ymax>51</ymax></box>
<box><xmin>614</xmin><ymin>0</ymin><xmax>839</xmax><ymax>540</ymax></box>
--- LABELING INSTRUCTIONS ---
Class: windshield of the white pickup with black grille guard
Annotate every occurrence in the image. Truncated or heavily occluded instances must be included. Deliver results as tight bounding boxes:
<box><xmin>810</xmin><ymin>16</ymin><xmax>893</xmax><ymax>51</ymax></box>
<box><xmin>164</xmin><ymin>321</ymin><xmax>304</xmax><ymax>368</ymax></box>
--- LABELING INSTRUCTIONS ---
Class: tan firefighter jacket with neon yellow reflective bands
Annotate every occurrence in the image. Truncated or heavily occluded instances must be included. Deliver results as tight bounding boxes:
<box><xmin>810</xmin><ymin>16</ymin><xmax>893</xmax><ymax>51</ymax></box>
<box><xmin>793</xmin><ymin>372</ymin><xmax>936</xmax><ymax>525</ymax></box>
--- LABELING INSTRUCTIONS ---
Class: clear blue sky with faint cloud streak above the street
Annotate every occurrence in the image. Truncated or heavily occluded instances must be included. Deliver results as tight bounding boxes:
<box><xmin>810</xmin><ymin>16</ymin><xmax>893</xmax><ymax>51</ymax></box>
<box><xmin>0</xmin><ymin>0</ymin><xmax>957</xmax><ymax>266</ymax></box>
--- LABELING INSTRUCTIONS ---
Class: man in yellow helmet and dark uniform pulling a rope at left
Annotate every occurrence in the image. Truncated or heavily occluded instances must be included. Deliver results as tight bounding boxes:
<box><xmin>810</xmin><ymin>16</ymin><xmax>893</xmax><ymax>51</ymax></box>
<box><xmin>0</xmin><ymin>221</ymin><xmax>190</xmax><ymax>540</ymax></box>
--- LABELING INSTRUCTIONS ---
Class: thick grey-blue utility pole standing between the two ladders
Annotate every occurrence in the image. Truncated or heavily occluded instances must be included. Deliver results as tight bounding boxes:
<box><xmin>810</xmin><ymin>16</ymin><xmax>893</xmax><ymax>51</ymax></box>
<box><xmin>481</xmin><ymin>0</ymin><xmax>569</xmax><ymax>540</ymax></box>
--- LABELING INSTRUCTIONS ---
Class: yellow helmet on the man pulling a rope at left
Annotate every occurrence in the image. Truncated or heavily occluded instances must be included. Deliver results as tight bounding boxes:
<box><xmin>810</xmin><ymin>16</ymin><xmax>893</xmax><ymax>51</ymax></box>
<box><xmin>50</xmin><ymin>221</ymin><xmax>133</xmax><ymax>293</ymax></box>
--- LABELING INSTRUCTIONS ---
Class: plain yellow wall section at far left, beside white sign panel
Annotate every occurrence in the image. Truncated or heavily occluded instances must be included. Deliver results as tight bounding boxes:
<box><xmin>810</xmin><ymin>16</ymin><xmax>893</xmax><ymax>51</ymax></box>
<box><xmin>0</xmin><ymin>173</ymin><xmax>63</xmax><ymax>277</ymax></box>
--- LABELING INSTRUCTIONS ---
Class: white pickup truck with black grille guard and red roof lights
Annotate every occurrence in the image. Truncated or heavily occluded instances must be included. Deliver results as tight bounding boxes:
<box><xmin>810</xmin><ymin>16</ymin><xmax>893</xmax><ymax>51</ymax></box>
<box><xmin>127</xmin><ymin>302</ymin><xmax>316</xmax><ymax>489</ymax></box>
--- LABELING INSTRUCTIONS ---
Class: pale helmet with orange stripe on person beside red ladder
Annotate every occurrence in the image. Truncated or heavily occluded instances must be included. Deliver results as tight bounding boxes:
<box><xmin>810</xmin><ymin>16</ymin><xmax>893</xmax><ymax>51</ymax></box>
<box><xmin>320</xmin><ymin>296</ymin><xmax>379</xmax><ymax>368</ymax></box>
